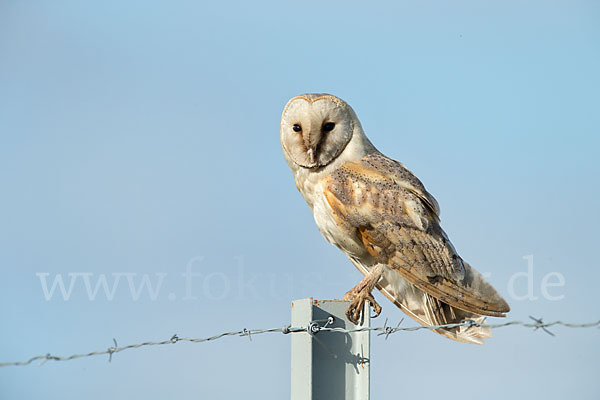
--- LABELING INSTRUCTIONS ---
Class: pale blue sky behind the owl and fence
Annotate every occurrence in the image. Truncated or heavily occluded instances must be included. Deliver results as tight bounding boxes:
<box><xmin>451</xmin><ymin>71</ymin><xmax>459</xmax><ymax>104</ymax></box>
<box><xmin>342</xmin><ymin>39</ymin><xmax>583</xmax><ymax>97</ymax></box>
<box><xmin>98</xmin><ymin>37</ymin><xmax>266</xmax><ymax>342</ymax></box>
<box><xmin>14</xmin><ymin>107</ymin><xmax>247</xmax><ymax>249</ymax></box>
<box><xmin>0</xmin><ymin>0</ymin><xmax>600</xmax><ymax>400</ymax></box>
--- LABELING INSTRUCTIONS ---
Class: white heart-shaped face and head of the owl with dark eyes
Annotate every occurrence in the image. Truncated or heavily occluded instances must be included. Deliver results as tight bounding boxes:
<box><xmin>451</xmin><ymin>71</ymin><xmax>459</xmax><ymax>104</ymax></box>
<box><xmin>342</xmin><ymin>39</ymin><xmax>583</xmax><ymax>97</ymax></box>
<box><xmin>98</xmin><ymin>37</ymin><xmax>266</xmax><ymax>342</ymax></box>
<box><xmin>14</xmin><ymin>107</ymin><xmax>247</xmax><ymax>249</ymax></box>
<box><xmin>281</xmin><ymin>94</ymin><xmax>354</xmax><ymax>168</ymax></box>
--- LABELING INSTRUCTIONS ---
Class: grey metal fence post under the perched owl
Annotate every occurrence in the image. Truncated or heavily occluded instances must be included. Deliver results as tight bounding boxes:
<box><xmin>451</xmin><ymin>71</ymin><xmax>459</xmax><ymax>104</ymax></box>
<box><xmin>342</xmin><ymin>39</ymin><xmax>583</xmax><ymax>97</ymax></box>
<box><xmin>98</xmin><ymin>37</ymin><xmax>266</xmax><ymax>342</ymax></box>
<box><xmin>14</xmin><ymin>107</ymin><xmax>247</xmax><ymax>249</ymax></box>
<box><xmin>291</xmin><ymin>298</ymin><xmax>370</xmax><ymax>400</ymax></box>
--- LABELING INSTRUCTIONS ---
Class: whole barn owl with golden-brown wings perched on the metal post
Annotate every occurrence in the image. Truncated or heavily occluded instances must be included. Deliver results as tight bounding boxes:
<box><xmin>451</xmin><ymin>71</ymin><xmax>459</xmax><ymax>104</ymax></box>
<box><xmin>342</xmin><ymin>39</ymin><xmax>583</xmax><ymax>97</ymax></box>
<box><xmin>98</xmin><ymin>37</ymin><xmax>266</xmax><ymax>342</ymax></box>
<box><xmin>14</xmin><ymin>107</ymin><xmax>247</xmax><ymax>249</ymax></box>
<box><xmin>280</xmin><ymin>94</ymin><xmax>510</xmax><ymax>344</ymax></box>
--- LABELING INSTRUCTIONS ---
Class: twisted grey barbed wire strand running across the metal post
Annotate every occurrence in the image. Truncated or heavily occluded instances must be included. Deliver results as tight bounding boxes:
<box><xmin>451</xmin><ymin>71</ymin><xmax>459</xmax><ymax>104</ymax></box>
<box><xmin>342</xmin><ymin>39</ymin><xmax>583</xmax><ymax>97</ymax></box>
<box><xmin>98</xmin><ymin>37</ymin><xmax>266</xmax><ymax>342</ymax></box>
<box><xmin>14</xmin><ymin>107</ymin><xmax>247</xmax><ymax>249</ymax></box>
<box><xmin>0</xmin><ymin>316</ymin><xmax>600</xmax><ymax>367</ymax></box>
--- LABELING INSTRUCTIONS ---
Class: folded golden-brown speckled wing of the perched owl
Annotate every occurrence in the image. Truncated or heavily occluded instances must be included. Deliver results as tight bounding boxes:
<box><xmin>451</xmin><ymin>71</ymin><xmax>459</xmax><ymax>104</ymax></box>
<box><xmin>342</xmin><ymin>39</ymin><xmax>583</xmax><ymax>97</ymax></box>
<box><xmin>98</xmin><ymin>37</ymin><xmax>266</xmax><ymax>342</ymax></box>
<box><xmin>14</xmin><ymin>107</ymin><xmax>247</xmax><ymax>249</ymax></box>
<box><xmin>323</xmin><ymin>153</ymin><xmax>510</xmax><ymax>316</ymax></box>
